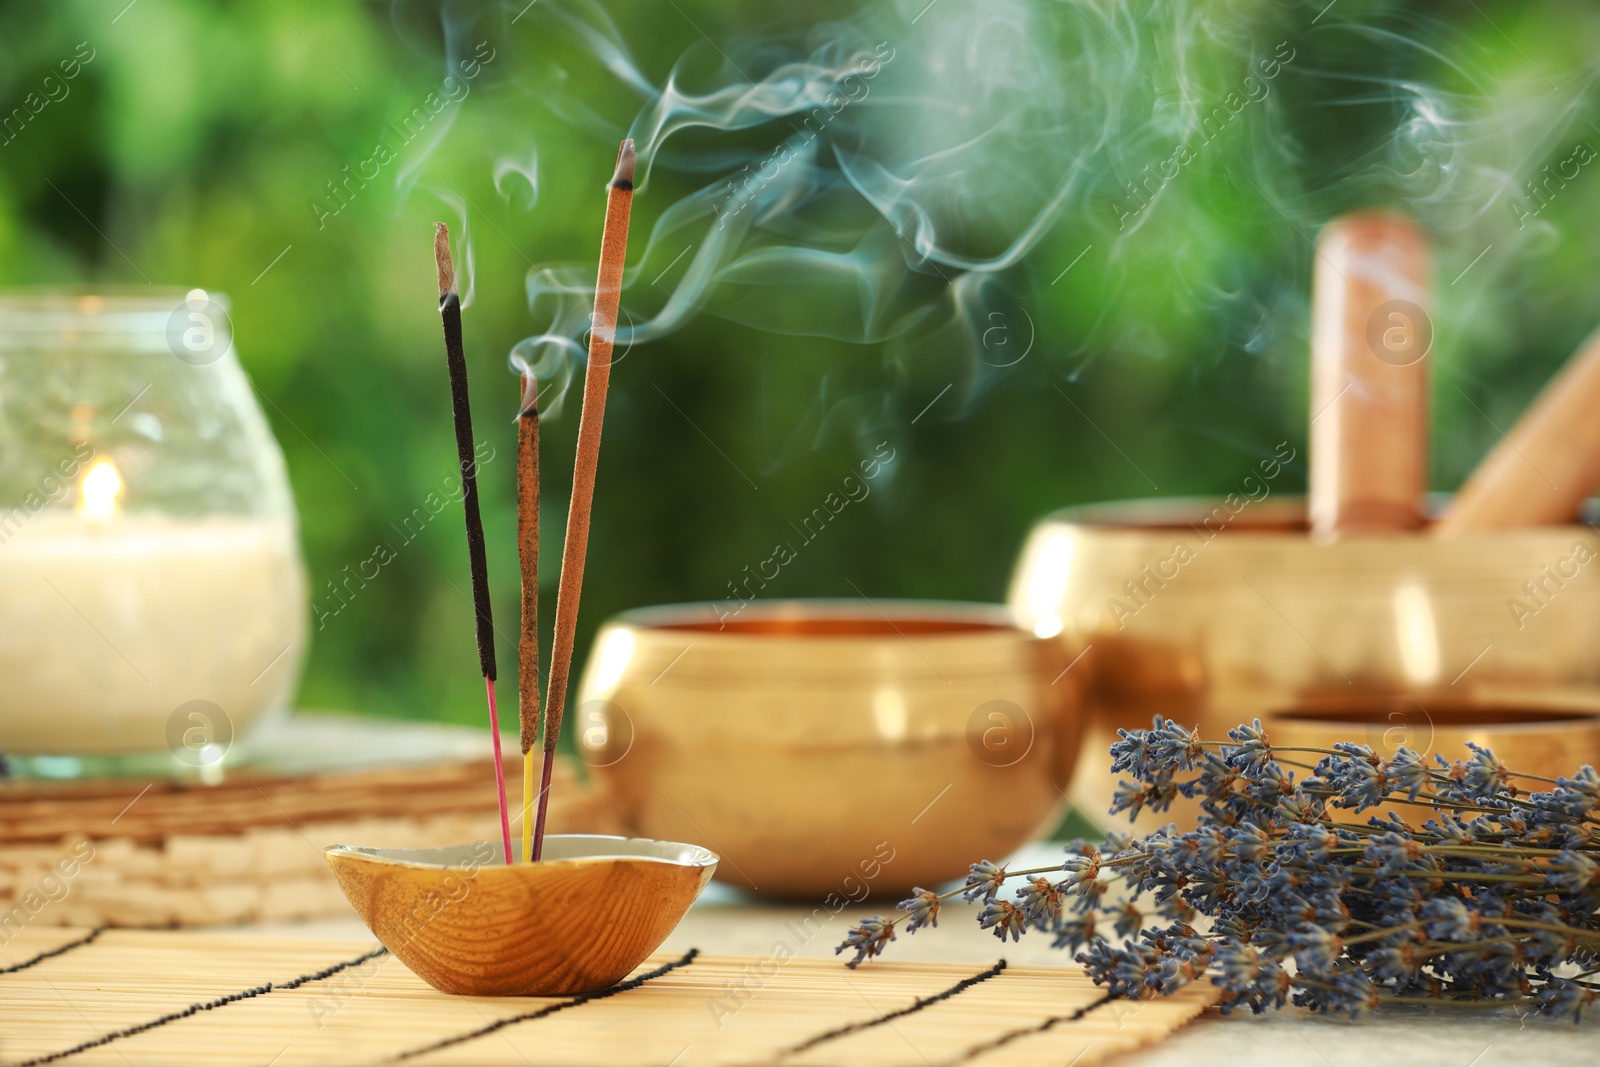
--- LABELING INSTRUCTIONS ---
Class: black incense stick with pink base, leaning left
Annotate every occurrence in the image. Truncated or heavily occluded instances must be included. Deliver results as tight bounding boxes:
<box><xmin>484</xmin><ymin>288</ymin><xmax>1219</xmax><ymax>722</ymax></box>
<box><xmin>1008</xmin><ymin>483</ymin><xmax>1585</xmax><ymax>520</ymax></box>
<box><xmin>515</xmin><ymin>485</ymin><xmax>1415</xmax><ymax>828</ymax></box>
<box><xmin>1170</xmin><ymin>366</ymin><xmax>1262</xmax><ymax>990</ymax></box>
<box><xmin>434</xmin><ymin>222</ymin><xmax>510</xmax><ymax>864</ymax></box>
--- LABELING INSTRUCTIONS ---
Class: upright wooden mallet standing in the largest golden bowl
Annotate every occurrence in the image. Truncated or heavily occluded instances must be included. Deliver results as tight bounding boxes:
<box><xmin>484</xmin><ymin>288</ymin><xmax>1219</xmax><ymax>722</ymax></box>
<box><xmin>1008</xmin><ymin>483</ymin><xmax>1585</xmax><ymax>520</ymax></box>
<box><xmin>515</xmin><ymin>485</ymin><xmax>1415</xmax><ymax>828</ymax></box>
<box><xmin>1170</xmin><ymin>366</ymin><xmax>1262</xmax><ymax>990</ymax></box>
<box><xmin>1309</xmin><ymin>211</ymin><xmax>1434</xmax><ymax>541</ymax></box>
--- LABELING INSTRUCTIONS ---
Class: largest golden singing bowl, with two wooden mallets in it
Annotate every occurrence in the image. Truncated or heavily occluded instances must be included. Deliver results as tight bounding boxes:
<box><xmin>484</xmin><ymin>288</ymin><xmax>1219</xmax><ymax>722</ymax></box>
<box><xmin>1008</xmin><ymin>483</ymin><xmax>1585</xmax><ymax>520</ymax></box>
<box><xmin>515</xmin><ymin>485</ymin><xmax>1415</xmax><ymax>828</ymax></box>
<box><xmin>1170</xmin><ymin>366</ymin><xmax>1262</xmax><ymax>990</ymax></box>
<box><xmin>1010</xmin><ymin>495</ymin><xmax>1600</xmax><ymax>829</ymax></box>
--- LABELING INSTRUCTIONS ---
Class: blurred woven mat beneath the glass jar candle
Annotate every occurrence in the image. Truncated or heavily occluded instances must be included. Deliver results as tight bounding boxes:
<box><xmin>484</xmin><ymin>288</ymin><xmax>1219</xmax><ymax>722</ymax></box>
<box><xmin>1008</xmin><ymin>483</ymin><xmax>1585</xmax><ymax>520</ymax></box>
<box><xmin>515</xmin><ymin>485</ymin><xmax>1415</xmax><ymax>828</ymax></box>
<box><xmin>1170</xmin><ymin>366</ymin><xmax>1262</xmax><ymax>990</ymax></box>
<box><xmin>0</xmin><ymin>720</ymin><xmax>621</xmax><ymax>937</ymax></box>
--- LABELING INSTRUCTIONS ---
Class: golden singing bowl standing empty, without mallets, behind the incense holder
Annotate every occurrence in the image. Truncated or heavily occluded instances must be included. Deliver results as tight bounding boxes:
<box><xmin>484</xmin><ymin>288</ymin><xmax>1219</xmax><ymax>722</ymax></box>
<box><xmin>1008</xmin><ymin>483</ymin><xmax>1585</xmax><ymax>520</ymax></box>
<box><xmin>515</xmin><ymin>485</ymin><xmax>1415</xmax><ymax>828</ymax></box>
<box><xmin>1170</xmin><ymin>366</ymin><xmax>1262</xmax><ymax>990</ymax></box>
<box><xmin>573</xmin><ymin>600</ymin><xmax>1078</xmax><ymax>910</ymax></box>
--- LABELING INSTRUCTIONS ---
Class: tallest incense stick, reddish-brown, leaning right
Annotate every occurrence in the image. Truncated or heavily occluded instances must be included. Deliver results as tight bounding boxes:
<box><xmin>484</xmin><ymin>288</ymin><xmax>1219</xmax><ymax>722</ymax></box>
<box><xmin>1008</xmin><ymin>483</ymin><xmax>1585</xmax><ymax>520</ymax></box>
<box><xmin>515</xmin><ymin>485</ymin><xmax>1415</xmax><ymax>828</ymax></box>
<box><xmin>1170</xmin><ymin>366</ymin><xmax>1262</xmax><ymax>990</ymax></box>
<box><xmin>533</xmin><ymin>139</ymin><xmax>637</xmax><ymax>859</ymax></box>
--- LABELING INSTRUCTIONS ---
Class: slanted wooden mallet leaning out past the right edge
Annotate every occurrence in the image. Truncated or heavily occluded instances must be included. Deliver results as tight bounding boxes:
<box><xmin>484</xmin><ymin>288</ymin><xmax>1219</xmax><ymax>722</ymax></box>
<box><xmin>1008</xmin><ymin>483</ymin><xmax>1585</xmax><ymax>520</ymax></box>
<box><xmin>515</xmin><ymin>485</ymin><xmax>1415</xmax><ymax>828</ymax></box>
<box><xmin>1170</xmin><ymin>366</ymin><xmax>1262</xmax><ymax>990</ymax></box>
<box><xmin>1434</xmin><ymin>321</ymin><xmax>1600</xmax><ymax>537</ymax></box>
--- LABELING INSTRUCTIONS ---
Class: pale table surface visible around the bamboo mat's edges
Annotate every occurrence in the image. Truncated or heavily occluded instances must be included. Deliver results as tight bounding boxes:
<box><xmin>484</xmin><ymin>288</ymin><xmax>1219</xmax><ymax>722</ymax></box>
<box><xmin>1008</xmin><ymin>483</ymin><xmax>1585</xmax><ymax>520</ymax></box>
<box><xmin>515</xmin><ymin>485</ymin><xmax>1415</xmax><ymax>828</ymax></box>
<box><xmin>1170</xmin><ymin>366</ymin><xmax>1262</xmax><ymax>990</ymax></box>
<box><xmin>248</xmin><ymin>846</ymin><xmax>1600</xmax><ymax>1067</ymax></box>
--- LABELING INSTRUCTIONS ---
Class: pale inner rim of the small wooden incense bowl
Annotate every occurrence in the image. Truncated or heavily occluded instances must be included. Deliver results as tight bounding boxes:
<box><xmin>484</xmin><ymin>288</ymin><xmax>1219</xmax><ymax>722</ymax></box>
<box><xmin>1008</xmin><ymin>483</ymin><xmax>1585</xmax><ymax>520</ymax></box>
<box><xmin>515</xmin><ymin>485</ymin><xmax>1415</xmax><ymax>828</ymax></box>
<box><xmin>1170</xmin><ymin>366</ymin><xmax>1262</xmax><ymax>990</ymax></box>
<box><xmin>322</xmin><ymin>833</ymin><xmax>720</xmax><ymax>880</ymax></box>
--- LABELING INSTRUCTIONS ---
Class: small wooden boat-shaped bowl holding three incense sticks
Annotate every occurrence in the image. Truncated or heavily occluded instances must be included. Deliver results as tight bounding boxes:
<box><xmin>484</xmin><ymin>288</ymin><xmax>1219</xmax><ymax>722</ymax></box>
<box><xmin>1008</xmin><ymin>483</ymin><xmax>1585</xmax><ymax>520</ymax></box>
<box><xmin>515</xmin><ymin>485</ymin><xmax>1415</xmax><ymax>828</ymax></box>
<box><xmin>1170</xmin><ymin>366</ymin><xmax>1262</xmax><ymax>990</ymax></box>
<box><xmin>323</xmin><ymin>833</ymin><xmax>717</xmax><ymax>997</ymax></box>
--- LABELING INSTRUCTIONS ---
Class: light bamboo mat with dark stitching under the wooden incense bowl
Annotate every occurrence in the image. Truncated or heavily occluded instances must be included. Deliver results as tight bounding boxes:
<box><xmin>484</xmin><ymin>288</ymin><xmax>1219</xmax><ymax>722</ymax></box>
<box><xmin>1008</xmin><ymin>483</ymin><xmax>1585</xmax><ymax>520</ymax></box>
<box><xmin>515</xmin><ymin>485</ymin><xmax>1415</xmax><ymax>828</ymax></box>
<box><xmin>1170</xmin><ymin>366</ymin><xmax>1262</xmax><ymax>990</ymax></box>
<box><xmin>0</xmin><ymin>928</ymin><xmax>1214</xmax><ymax>1067</ymax></box>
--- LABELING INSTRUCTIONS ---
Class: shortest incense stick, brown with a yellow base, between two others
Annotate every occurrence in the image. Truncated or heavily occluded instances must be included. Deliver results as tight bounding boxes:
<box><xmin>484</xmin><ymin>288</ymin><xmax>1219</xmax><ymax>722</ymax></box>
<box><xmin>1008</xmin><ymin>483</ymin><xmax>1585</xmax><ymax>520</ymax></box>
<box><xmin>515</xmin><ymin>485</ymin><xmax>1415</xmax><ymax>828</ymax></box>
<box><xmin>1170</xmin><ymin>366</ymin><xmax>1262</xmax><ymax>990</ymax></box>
<box><xmin>517</xmin><ymin>374</ymin><xmax>550</xmax><ymax>861</ymax></box>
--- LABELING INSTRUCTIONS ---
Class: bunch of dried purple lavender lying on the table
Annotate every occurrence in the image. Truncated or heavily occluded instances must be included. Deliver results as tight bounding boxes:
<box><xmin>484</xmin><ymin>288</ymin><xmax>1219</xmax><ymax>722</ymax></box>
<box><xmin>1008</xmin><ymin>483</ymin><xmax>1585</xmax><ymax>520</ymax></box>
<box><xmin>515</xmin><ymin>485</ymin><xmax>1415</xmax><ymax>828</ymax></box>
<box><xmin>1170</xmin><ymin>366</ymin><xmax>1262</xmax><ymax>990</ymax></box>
<box><xmin>837</xmin><ymin>717</ymin><xmax>1600</xmax><ymax>1022</ymax></box>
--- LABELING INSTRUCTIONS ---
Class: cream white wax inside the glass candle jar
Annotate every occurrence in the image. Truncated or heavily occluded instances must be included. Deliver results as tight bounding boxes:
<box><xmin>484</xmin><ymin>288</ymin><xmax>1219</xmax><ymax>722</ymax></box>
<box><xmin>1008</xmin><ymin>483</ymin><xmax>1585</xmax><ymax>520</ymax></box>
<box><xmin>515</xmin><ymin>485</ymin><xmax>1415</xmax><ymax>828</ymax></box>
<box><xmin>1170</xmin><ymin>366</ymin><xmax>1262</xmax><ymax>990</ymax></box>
<box><xmin>0</xmin><ymin>507</ymin><xmax>306</xmax><ymax>755</ymax></box>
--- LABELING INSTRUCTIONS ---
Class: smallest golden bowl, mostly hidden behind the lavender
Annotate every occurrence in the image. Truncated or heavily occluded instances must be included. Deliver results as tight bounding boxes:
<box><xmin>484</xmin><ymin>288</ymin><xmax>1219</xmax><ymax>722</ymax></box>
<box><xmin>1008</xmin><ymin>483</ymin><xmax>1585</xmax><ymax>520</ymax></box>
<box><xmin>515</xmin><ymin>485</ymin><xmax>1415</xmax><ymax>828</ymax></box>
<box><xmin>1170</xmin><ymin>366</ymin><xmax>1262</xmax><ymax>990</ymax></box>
<box><xmin>1267</xmin><ymin>697</ymin><xmax>1600</xmax><ymax>792</ymax></box>
